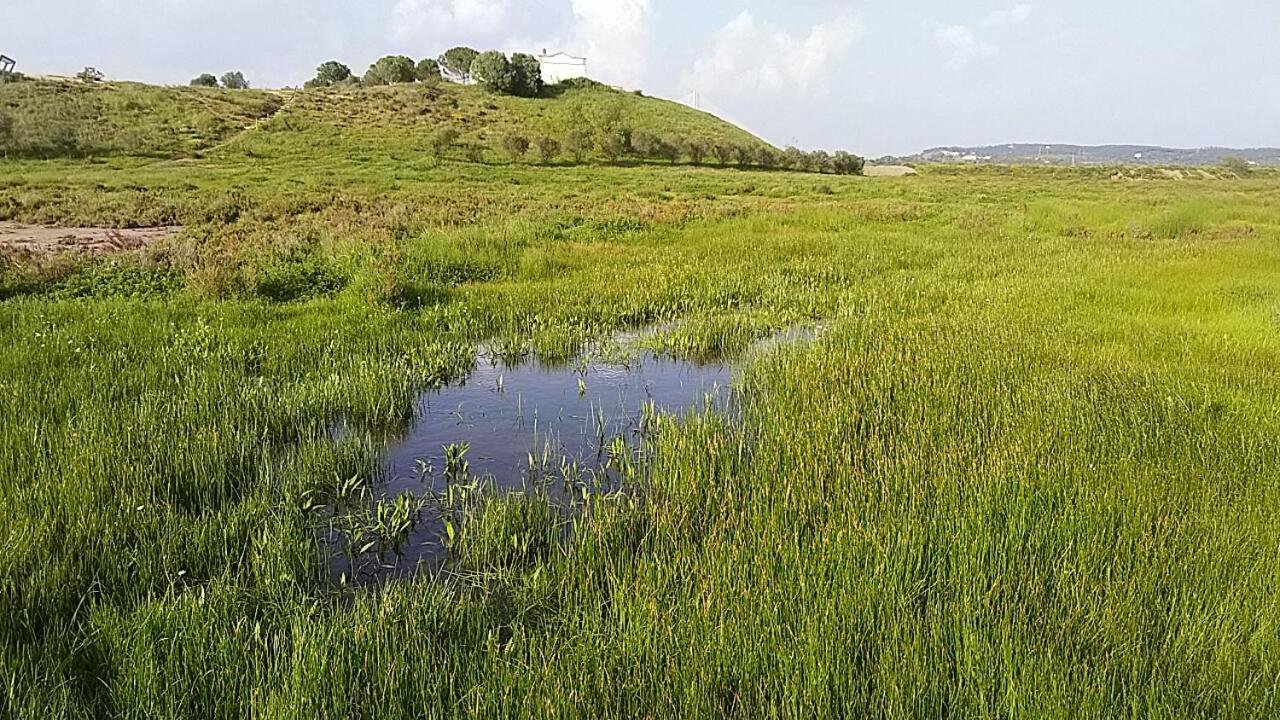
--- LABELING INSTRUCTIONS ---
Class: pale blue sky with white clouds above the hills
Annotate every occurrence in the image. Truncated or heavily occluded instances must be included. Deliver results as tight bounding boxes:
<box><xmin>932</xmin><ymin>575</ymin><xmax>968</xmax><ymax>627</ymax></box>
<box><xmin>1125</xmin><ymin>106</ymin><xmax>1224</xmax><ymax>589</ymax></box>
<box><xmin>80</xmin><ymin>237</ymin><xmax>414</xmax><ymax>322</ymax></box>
<box><xmin>0</xmin><ymin>0</ymin><xmax>1280</xmax><ymax>156</ymax></box>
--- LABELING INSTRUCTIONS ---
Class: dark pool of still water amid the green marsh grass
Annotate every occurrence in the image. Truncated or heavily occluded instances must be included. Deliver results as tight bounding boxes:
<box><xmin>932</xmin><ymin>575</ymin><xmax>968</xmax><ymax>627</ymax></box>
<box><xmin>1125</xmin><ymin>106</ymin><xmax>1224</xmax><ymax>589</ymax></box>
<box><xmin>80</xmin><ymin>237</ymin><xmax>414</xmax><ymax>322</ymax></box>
<box><xmin>329</xmin><ymin>352</ymin><xmax>731</xmax><ymax>583</ymax></box>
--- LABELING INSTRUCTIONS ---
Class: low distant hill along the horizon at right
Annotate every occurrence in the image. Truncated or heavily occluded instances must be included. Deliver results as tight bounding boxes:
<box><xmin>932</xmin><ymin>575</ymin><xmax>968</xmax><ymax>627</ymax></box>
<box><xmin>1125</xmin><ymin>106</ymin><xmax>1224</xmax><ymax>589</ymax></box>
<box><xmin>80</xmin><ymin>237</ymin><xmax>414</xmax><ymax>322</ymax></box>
<box><xmin>883</xmin><ymin>143</ymin><xmax>1280</xmax><ymax>167</ymax></box>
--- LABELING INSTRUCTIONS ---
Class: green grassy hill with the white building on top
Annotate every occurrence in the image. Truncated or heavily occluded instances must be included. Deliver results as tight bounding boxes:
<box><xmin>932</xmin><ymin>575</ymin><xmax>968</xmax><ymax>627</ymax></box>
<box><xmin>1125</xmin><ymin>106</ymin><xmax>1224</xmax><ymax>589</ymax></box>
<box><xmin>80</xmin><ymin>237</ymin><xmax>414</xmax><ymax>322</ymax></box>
<box><xmin>0</xmin><ymin>81</ymin><xmax>764</xmax><ymax>159</ymax></box>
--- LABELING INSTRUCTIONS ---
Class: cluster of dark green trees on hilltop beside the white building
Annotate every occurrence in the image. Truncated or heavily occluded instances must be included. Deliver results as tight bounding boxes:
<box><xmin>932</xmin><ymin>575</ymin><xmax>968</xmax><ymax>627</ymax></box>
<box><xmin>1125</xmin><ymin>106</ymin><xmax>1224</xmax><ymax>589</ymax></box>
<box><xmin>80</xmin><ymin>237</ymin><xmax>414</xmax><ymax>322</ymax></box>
<box><xmin>306</xmin><ymin>46</ymin><xmax>543</xmax><ymax>97</ymax></box>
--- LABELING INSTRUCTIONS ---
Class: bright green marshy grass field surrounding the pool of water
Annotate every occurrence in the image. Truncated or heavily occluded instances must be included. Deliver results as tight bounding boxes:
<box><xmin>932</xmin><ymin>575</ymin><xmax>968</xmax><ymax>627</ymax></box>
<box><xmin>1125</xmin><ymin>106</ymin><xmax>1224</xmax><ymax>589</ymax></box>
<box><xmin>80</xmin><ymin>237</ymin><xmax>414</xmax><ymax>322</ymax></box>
<box><xmin>0</xmin><ymin>82</ymin><xmax>1280</xmax><ymax>719</ymax></box>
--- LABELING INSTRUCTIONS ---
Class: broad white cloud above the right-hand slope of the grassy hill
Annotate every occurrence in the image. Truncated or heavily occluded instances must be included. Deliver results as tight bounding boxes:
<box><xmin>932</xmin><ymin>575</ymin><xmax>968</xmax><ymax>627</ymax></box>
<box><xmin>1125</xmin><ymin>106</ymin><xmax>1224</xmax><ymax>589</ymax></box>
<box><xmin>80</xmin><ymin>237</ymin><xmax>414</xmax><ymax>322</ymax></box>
<box><xmin>684</xmin><ymin>10</ymin><xmax>863</xmax><ymax>95</ymax></box>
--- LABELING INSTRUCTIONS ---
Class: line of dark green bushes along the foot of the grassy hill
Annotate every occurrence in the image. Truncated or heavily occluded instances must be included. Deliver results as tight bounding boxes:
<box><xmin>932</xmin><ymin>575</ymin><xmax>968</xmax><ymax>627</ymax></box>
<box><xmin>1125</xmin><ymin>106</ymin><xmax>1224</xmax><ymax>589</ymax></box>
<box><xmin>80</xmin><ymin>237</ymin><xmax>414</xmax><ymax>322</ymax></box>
<box><xmin>430</xmin><ymin>128</ymin><xmax>865</xmax><ymax>176</ymax></box>
